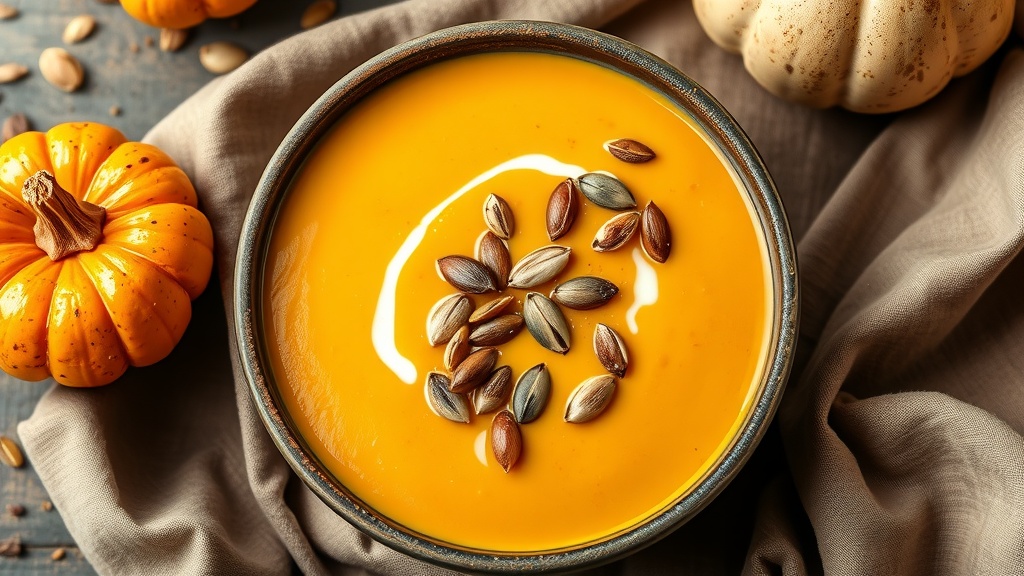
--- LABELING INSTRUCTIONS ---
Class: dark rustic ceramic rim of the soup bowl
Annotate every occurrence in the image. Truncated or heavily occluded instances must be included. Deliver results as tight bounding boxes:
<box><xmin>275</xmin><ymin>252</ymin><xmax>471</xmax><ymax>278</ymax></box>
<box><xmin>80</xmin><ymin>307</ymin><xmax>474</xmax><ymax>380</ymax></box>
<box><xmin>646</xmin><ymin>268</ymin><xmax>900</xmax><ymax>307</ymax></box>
<box><xmin>232</xmin><ymin>20</ymin><xmax>800</xmax><ymax>573</ymax></box>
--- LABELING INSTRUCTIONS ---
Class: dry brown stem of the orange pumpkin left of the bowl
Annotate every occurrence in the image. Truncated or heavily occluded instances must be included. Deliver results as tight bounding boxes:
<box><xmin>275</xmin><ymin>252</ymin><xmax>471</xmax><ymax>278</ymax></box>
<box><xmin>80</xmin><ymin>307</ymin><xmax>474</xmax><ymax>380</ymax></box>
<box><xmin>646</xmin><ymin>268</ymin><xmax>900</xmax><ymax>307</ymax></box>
<box><xmin>22</xmin><ymin>170</ymin><xmax>106</xmax><ymax>261</ymax></box>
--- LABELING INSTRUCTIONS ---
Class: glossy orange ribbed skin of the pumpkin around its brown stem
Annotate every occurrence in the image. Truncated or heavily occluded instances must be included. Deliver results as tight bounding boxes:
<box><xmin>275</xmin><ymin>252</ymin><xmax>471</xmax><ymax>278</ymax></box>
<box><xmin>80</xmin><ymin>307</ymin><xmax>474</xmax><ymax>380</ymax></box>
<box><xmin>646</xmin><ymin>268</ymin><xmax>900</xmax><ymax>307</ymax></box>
<box><xmin>0</xmin><ymin>123</ymin><xmax>213</xmax><ymax>386</ymax></box>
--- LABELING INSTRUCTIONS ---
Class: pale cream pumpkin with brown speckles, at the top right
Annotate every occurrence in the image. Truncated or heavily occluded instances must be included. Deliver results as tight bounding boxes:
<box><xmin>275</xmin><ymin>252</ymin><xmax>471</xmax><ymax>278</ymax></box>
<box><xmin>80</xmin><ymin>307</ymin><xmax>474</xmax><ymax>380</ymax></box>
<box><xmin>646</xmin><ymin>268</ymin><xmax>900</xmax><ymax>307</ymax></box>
<box><xmin>693</xmin><ymin>0</ymin><xmax>1014</xmax><ymax>113</ymax></box>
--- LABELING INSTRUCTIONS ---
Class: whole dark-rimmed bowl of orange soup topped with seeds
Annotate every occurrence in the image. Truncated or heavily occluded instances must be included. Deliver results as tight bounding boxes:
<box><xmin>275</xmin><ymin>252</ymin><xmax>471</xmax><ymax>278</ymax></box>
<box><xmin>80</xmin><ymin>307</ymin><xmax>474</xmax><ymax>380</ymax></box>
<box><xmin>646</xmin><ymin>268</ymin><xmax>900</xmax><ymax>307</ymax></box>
<box><xmin>234</xmin><ymin>22</ymin><xmax>799</xmax><ymax>573</ymax></box>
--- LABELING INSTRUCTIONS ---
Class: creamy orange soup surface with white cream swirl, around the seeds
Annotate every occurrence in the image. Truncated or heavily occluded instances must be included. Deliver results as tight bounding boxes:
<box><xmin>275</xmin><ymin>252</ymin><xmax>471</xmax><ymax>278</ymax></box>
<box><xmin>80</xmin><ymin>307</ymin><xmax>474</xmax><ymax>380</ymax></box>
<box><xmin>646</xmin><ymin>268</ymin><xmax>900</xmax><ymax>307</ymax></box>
<box><xmin>262</xmin><ymin>53</ymin><xmax>770</xmax><ymax>551</ymax></box>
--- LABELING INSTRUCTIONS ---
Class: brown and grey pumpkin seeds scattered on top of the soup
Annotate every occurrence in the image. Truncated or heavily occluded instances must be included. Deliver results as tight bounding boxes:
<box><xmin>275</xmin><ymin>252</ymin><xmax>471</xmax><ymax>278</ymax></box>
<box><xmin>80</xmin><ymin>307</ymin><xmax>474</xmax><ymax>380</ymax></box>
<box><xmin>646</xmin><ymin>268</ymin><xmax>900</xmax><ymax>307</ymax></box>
<box><xmin>425</xmin><ymin>139</ymin><xmax>672</xmax><ymax>472</ymax></box>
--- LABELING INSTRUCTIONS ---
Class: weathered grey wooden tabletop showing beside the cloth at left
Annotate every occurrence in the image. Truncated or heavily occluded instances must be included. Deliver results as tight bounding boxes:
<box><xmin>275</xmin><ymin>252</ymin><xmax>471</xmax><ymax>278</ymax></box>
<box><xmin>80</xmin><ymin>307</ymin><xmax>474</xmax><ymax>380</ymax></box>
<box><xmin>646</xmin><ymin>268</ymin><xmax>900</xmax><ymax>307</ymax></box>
<box><xmin>0</xmin><ymin>0</ymin><xmax>393</xmax><ymax>575</ymax></box>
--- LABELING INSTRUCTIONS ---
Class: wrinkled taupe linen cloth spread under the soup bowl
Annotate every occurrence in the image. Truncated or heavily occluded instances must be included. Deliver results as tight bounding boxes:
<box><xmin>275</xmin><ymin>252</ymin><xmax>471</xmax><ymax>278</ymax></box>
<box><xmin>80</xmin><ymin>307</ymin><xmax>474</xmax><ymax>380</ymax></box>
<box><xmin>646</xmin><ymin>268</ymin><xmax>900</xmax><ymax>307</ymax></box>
<box><xmin>18</xmin><ymin>0</ymin><xmax>1024</xmax><ymax>575</ymax></box>
